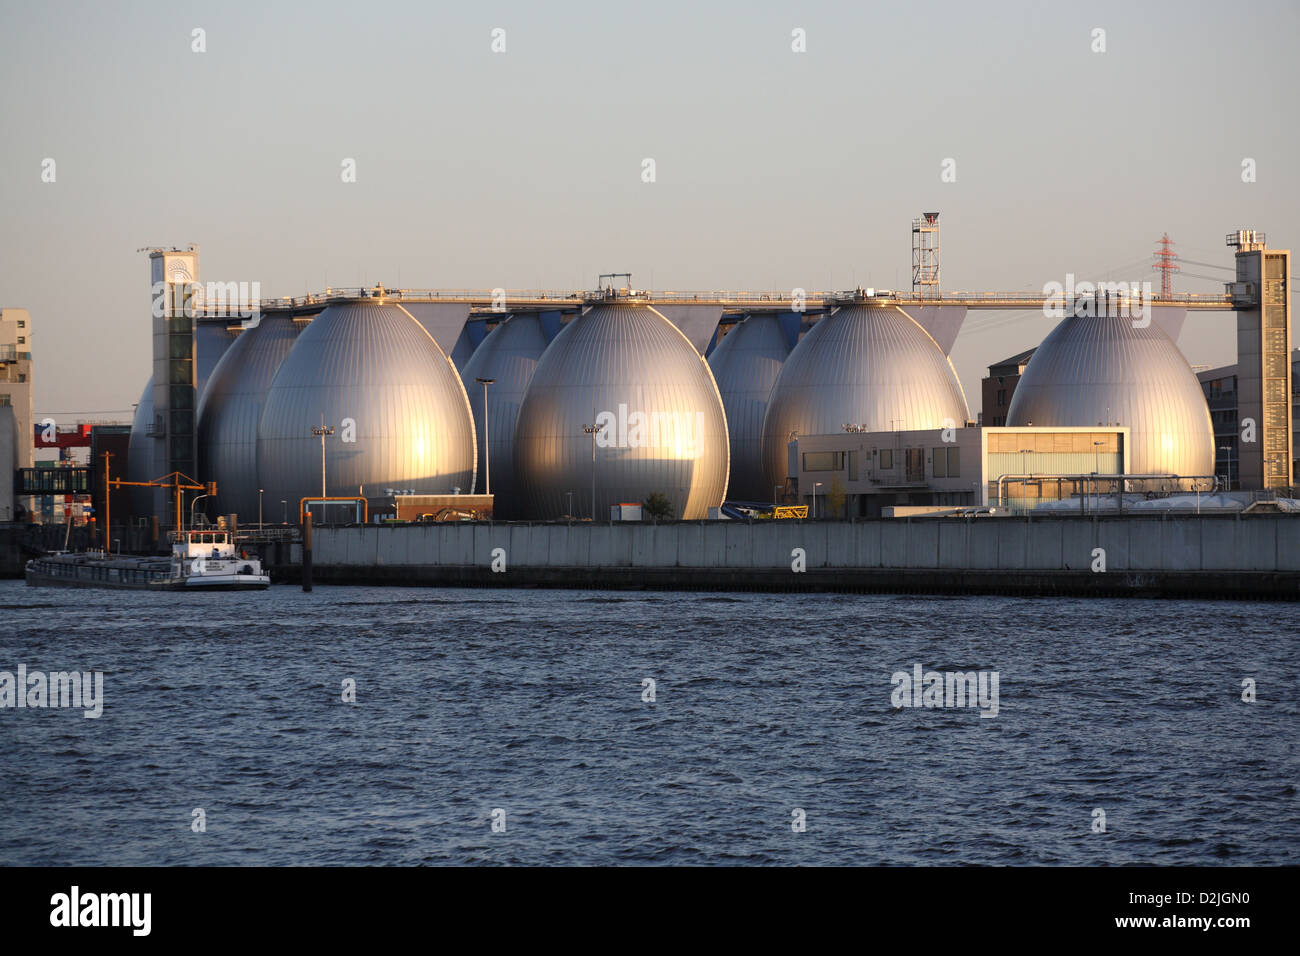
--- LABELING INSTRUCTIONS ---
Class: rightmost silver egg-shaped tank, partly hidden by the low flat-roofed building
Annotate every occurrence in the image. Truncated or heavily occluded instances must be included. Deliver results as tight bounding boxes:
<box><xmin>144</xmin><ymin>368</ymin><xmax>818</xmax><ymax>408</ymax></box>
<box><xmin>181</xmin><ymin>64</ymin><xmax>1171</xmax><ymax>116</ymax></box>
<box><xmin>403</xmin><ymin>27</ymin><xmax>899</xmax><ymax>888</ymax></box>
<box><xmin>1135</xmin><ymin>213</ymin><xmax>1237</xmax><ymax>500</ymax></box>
<box><xmin>1006</xmin><ymin>316</ymin><xmax>1214</xmax><ymax>475</ymax></box>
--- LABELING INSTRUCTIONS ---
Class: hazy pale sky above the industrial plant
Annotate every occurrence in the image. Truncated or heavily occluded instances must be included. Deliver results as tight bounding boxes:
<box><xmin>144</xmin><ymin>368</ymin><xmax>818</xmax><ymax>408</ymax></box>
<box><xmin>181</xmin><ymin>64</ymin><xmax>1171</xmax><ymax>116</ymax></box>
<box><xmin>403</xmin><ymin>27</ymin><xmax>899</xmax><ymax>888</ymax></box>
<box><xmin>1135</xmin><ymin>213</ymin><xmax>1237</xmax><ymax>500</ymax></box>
<box><xmin>0</xmin><ymin>0</ymin><xmax>1300</xmax><ymax>418</ymax></box>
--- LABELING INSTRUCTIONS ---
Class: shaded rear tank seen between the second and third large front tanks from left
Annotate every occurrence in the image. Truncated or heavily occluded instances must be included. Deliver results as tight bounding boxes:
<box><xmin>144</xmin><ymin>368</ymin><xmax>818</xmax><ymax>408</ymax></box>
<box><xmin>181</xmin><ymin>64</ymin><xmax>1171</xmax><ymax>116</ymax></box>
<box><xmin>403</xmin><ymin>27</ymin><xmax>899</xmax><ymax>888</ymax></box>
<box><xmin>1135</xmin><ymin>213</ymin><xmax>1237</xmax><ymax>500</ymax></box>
<box><xmin>709</xmin><ymin>315</ymin><xmax>790</xmax><ymax>502</ymax></box>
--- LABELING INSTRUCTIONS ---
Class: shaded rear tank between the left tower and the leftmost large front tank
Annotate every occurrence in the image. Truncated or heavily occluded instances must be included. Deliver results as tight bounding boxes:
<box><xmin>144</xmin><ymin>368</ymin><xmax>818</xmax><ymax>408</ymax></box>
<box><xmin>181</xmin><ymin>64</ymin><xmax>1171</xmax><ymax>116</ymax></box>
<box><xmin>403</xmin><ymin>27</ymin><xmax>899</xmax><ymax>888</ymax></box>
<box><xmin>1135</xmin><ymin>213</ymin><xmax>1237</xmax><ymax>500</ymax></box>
<box><xmin>199</xmin><ymin>313</ymin><xmax>298</xmax><ymax>524</ymax></box>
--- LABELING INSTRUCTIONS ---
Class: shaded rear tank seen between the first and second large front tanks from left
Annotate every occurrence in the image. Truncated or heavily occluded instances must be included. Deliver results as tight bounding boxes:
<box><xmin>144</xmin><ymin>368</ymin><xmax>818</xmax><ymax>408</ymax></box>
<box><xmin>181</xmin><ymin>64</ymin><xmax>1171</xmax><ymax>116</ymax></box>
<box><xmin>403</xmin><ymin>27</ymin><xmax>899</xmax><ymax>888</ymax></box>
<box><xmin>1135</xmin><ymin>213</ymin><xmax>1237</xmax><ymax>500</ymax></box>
<box><xmin>460</xmin><ymin>315</ymin><xmax>546</xmax><ymax>518</ymax></box>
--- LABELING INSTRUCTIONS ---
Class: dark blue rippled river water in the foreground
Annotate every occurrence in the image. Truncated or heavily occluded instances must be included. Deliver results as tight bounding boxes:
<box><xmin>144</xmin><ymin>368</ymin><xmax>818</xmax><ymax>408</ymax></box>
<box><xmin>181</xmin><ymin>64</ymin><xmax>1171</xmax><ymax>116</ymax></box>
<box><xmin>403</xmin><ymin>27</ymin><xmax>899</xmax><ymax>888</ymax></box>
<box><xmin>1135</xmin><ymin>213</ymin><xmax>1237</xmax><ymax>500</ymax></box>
<box><xmin>0</xmin><ymin>581</ymin><xmax>1300</xmax><ymax>865</ymax></box>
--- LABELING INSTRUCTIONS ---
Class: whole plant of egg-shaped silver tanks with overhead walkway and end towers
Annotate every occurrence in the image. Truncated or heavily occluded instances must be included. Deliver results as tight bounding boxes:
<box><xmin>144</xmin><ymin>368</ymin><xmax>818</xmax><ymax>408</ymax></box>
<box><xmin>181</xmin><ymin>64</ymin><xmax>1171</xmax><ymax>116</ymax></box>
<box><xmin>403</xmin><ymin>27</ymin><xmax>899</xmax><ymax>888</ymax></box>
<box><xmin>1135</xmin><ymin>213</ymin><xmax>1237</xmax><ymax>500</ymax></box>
<box><xmin>106</xmin><ymin>222</ymin><xmax>1292</xmax><ymax>524</ymax></box>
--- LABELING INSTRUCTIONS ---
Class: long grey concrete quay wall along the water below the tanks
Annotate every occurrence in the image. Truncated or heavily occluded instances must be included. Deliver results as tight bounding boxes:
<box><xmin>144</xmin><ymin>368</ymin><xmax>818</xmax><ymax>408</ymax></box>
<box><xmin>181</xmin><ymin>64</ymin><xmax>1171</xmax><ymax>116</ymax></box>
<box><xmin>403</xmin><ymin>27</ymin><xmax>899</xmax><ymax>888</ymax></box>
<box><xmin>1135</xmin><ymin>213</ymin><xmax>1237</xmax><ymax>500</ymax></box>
<box><xmin>263</xmin><ymin>514</ymin><xmax>1300</xmax><ymax>600</ymax></box>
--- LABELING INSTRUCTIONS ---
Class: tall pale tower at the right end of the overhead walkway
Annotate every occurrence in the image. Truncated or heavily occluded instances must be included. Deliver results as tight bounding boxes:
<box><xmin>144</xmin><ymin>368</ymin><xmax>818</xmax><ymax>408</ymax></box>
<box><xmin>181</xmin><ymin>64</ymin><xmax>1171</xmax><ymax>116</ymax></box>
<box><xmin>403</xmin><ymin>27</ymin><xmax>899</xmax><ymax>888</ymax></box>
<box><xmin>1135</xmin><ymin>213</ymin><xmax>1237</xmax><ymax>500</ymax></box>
<box><xmin>1227</xmin><ymin>229</ymin><xmax>1295</xmax><ymax>489</ymax></box>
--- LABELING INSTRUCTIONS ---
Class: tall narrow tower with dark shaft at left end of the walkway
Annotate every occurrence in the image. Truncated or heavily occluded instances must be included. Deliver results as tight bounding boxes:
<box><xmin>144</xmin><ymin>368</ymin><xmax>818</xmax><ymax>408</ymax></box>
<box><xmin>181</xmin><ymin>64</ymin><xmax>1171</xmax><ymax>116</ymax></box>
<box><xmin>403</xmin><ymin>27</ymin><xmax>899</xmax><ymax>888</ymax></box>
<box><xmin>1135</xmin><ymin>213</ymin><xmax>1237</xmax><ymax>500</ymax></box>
<box><xmin>148</xmin><ymin>246</ymin><xmax>199</xmax><ymax>522</ymax></box>
